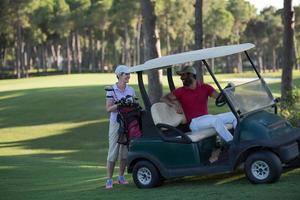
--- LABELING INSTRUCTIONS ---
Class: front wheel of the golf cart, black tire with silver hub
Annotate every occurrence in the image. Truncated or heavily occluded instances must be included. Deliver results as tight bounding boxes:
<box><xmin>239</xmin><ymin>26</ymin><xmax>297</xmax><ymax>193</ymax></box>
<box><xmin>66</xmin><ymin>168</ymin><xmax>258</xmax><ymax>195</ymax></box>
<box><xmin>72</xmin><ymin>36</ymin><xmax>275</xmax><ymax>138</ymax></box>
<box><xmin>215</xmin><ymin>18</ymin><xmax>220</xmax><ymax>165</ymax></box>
<box><xmin>244</xmin><ymin>151</ymin><xmax>282</xmax><ymax>184</ymax></box>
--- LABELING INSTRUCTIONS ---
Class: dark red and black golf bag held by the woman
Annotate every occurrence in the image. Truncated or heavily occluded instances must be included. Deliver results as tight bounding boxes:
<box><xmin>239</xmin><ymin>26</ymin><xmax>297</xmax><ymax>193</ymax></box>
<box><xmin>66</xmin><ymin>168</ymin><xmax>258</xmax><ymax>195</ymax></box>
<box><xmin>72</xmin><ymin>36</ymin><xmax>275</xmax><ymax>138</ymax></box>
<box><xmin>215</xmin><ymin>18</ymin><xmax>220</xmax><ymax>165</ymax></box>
<box><xmin>117</xmin><ymin>103</ymin><xmax>142</xmax><ymax>145</ymax></box>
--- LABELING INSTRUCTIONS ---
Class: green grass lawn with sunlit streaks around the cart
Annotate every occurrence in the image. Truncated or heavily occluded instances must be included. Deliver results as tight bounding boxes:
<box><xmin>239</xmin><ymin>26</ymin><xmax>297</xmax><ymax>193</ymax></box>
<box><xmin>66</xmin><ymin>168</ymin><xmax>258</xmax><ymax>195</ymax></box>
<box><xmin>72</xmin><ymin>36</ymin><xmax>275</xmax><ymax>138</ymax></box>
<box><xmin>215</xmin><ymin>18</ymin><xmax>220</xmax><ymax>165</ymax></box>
<box><xmin>0</xmin><ymin>71</ymin><xmax>300</xmax><ymax>200</ymax></box>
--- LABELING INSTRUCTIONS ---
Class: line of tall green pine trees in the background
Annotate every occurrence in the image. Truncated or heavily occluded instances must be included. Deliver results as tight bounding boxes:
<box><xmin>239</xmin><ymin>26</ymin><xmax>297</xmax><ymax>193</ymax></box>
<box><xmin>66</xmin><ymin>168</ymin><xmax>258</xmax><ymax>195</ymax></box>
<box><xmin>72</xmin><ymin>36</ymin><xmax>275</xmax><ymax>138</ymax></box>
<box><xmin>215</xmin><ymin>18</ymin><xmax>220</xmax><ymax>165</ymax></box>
<box><xmin>0</xmin><ymin>0</ymin><xmax>300</xmax><ymax>78</ymax></box>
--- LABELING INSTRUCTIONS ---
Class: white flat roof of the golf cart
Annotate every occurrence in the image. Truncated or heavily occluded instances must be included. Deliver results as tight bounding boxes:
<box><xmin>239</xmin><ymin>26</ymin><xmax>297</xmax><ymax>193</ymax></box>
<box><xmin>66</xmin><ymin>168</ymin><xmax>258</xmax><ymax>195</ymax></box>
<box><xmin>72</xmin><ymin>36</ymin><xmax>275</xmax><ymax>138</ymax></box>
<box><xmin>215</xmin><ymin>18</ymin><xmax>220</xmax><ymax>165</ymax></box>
<box><xmin>130</xmin><ymin>43</ymin><xmax>255</xmax><ymax>72</ymax></box>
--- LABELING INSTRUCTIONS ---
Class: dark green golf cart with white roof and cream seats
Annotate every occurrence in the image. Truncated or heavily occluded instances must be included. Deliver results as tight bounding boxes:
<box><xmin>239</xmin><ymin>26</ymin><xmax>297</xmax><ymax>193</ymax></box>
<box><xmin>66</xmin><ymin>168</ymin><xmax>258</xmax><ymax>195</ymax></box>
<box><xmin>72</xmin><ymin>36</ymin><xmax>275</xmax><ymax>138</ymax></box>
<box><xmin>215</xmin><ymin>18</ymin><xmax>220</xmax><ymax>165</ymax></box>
<box><xmin>128</xmin><ymin>43</ymin><xmax>300</xmax><ymax>188</ymax></box>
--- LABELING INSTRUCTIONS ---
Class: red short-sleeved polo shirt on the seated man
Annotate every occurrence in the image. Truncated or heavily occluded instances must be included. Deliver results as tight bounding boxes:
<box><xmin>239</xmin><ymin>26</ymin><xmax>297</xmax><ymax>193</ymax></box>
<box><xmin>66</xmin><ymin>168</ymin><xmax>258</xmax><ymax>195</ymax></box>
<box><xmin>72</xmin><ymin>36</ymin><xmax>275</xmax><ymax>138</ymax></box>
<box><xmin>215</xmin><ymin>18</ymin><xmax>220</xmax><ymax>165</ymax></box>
<box><xmin>172</xmin><ymin>83</ymin><xmax>215</xmax><ymax>122</ymax></box>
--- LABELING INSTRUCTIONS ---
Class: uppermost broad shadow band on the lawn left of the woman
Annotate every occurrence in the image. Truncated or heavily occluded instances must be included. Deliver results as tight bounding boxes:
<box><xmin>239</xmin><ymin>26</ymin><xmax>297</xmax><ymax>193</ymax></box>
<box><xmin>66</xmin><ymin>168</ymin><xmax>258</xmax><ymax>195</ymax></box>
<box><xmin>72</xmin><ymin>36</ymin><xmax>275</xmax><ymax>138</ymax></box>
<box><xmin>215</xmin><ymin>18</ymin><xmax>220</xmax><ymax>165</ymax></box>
<box><xmin>0</xmin><ymin>85</ymin><xmax>142</xmax><ymax>128</ymax></box>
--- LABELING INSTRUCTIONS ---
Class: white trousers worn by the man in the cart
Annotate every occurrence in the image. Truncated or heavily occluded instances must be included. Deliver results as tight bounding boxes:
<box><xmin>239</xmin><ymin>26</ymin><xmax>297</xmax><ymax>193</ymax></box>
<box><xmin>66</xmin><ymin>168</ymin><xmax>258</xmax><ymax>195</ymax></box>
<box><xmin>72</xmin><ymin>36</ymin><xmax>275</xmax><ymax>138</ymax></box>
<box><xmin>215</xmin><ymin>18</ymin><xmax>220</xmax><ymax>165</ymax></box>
<box><xmin>190</xmin><ymin>112</ymin><xmax>237</xmax><ymax>142</ymax></box>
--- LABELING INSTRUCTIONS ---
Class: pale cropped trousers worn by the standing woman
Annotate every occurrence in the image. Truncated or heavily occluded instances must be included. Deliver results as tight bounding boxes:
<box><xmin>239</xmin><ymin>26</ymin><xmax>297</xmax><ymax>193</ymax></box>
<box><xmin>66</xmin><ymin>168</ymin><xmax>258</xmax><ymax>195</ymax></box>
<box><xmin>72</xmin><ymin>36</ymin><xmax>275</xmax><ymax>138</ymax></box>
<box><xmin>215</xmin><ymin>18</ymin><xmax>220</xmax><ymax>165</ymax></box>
<box><xmin>107</xmin><ymin>122</ymin><xmax>128</xmax><ymax>162</ymax></box>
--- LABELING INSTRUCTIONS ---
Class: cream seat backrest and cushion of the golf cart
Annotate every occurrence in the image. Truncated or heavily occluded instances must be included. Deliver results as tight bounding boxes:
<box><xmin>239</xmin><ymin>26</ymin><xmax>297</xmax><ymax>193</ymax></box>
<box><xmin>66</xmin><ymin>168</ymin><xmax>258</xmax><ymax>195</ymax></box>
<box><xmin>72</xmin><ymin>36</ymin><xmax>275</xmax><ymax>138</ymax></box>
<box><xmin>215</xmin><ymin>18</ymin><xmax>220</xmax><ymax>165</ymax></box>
<box><xmin>151</xmin><ymin>102</ymin><xmax>233</xmax><ymax>142</ymax></box>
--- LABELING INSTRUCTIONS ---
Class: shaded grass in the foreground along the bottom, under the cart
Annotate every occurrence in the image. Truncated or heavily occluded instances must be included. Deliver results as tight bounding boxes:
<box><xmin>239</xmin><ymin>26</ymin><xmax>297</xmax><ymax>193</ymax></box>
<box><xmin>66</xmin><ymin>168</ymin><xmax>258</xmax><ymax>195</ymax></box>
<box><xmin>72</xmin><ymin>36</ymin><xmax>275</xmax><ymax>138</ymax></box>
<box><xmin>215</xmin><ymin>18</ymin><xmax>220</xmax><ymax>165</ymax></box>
<box><xmin>0</xmin><ymin>157</ymin><xmax>300</xmax><ymax>200</ymax></box>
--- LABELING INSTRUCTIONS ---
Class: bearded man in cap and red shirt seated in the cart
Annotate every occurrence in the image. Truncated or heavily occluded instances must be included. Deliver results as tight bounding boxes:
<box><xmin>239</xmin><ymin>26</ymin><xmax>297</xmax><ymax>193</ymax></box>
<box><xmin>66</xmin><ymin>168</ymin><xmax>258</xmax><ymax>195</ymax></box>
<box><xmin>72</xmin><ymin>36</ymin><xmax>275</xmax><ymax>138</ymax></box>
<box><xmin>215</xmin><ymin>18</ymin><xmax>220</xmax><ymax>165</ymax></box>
<box><xmin>161</xmin><ymin>66</ymin><xmax>237</xmax><ymax>142</ymax></box>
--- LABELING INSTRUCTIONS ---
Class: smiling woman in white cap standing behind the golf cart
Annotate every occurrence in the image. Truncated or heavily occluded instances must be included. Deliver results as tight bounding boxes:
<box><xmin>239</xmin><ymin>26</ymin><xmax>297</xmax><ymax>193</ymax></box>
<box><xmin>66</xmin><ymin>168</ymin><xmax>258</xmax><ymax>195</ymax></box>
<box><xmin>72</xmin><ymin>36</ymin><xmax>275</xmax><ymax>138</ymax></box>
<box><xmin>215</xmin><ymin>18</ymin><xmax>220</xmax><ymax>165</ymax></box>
<box><xmin>105</xmin><ymin>65</ymin><xmax>135</xmax><ymax>189</ymax></box>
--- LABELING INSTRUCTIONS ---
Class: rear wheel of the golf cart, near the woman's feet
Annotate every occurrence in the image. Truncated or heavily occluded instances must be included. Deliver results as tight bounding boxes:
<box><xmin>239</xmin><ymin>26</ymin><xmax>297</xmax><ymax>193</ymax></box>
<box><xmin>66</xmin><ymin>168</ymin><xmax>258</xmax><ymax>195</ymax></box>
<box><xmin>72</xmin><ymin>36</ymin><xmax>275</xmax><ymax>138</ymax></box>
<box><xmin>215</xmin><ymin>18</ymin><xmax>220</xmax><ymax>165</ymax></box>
<box><xmin>132</xmin><ymin>161</ymin><xmax>163</xmax><ymax>188</ymax></box>
